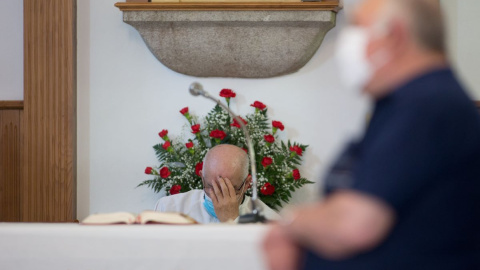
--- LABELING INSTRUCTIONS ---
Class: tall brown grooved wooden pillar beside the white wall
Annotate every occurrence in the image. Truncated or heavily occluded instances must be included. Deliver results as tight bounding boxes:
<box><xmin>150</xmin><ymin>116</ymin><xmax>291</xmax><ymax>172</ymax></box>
<box><xmin>21</xmin><ymin>0</ymin><xmax>76</xmax><ymax>222</ymax></box>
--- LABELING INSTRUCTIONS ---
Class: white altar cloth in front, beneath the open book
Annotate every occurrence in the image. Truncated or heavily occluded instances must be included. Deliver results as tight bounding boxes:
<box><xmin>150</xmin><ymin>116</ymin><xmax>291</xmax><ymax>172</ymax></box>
<box><xmin>0</xmin><ymin>223</ymin><xmax>266</xmax><ymax>270</ymax></box>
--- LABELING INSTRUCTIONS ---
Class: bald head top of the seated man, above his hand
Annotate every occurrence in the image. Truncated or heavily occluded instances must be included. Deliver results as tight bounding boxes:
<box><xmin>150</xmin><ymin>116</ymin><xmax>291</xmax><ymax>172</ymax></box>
<box><xmin>202</xmin><ymin>144</ymin><xmax>249</xmax><ymax>187</ymax></box>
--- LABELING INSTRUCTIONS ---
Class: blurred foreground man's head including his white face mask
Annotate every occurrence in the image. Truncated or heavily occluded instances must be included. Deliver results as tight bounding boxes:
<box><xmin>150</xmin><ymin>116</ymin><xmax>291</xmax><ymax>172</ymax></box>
<box><xmin>337</xmin><ymin>0</ymin><xmax>446</xmax><ymax>99</ymax></box>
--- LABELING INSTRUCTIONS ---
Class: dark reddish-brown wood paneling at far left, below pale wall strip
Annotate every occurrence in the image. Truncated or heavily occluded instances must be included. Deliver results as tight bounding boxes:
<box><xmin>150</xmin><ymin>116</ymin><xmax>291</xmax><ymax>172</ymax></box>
<box><xmin>0</xmin><ymin>109</ymin><xmax>22</xmax><ymax>222</ymax></box>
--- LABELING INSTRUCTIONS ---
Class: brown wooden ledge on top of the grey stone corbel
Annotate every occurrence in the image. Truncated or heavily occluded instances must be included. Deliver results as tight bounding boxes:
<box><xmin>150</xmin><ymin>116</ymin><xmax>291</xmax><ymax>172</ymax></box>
<box><xmin>115</xmin><ymin>0</ymin><xmax>340</xmax><ymax>12</ymax></box>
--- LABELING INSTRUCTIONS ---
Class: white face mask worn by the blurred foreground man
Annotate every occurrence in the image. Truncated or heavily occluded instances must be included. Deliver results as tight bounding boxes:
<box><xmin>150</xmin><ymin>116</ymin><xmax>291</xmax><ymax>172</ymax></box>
<box><xmin>335</xmin><ymin>26</ymin><xmax>374</xmax><ymax>92</ymax></box>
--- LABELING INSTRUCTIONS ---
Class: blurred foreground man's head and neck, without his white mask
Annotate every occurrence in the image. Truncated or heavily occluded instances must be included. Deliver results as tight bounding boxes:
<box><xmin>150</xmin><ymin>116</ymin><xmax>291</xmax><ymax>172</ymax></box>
<box><xmin>352</xmin><ymin>0</ymin><xmax>447</xmax><ymax>99</ymax></box>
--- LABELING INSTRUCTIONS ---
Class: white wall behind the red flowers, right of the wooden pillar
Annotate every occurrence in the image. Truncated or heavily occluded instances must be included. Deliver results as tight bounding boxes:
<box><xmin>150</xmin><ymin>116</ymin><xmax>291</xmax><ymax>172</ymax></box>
<box><xmin>78</xmin><ymin>0</ymin><xmax>366</xmax><ymax>219</ymax></box>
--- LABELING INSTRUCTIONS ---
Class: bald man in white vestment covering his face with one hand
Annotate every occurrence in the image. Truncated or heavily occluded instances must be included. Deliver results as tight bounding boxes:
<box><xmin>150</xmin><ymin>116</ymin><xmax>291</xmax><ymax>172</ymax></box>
<box><xmin>155</xmin><ymin>144</ymin><xmax>279</xmax><ymax>223</ymax></box>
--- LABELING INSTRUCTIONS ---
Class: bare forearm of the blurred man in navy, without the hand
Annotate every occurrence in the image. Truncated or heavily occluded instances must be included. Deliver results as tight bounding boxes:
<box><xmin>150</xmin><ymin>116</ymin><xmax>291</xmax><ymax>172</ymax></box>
<box><xmin>285</xmin><ymin>192</ymin><xmax>393</xmax><ymax>259</ymax></box>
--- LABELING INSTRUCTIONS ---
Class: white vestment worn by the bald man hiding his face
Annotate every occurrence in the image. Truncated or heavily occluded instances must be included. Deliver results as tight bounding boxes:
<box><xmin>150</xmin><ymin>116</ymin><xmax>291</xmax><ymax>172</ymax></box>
<box><xmin>155</xmin><ymin>189</ymin><xmax>280</xmax><ymax>223</ymax></box>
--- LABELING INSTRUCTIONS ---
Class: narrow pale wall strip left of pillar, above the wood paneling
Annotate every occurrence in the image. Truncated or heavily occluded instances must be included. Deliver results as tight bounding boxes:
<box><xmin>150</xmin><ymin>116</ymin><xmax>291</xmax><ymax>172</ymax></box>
<box><xmin>0</xmin><ymin>0</ymin><xmax>23</xmax><ymax>100</ymax></box>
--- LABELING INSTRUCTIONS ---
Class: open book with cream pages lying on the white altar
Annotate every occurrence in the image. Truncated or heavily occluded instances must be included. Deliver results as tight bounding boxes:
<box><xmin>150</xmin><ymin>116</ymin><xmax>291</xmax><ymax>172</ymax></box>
<box><xmin>81</xmin><ymin>211</ymin><xmax>198</xmax><ymax>225</ymax></box>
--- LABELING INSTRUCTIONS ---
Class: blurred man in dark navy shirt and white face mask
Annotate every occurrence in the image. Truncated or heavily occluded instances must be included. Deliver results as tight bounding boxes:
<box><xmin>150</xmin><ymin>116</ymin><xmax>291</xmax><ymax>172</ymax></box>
<box><xmin>264</xmin><ymin>0</ymin><xmax>480</xmax><ymax>270</ymax></box>
